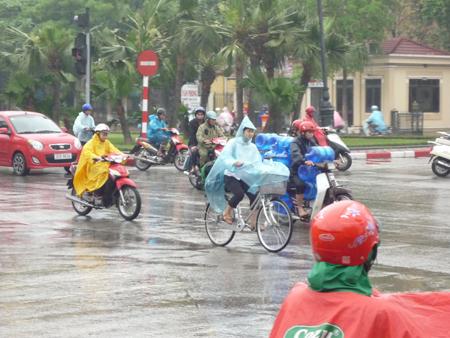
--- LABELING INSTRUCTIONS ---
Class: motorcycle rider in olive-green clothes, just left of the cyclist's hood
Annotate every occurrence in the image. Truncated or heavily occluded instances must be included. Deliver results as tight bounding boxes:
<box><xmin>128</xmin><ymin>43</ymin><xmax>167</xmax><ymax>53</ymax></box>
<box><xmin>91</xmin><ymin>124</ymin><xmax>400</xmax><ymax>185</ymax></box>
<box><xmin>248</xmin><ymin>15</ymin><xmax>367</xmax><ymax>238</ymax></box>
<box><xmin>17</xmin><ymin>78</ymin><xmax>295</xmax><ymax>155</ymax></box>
<box><xmin>196</xmin><ymin>111</ymin><xmax>224</xmax><ymax>167</ymax></box>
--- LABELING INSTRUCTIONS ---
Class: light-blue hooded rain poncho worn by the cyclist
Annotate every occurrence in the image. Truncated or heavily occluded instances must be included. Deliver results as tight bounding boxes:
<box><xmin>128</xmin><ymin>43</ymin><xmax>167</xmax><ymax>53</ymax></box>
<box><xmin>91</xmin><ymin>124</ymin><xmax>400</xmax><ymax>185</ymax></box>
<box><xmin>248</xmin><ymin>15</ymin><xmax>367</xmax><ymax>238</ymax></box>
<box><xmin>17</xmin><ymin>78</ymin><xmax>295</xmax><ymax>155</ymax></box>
<box><xmin>205</xmin><ymin>116</ymin><xmax>289</xmax><ymax>212</ymax></box>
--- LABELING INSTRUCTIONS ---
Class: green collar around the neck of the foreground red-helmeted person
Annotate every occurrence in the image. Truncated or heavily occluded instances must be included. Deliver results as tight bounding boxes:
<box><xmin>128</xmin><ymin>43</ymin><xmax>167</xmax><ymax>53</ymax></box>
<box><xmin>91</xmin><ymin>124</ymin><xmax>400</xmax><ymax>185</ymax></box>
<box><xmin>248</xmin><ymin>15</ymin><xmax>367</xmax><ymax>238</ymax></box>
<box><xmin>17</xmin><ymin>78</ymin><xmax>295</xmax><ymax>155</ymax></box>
<box><xmin>308</xmin><ymin>262</ymin><xmax>372</xmax><ymax>296</ymax></box>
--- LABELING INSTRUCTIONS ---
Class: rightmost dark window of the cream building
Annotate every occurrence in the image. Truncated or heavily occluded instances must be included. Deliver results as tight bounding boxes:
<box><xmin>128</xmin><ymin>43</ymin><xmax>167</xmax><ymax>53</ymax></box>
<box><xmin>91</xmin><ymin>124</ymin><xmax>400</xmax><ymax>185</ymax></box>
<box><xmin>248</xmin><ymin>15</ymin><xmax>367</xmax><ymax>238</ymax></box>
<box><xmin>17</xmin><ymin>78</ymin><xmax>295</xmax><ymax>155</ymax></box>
<box><xmin>408</xmin><ymin>79</ymin><xmax>439</xmax><ymax>113</ymax></box>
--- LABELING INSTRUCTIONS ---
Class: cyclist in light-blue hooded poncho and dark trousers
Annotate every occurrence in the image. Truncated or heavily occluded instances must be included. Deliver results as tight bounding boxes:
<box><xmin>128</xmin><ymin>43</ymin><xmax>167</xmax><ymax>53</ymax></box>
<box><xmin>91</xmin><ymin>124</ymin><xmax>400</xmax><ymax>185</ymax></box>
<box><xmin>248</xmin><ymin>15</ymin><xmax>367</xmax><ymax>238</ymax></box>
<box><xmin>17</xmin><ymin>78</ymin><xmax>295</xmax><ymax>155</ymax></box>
<box><xmin>205</xmin><ymin>116</ymin><xmax>289</xmax><ymax>224</ymax></box>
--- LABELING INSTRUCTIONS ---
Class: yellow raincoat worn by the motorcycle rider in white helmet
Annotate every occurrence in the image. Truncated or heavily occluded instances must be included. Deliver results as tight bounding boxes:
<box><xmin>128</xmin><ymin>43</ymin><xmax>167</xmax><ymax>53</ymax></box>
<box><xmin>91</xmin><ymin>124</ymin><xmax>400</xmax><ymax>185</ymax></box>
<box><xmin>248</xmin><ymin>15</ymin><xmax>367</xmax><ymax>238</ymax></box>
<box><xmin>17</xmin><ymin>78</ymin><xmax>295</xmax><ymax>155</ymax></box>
<box><xmin>73</xmin><ymin>134</ymin><xmax>122</xmax><ymax>196</ymax></box>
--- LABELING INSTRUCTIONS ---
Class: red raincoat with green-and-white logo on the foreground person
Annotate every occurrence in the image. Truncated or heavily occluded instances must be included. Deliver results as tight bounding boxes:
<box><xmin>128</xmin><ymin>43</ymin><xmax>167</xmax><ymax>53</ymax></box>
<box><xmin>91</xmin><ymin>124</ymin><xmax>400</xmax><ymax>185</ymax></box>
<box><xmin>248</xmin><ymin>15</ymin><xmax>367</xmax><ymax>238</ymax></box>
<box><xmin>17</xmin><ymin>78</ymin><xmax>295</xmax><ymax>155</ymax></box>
<box><xmin>270</xmin><ymin>283</ymin><xmax>450</xmax><ymax>338</ymax></box>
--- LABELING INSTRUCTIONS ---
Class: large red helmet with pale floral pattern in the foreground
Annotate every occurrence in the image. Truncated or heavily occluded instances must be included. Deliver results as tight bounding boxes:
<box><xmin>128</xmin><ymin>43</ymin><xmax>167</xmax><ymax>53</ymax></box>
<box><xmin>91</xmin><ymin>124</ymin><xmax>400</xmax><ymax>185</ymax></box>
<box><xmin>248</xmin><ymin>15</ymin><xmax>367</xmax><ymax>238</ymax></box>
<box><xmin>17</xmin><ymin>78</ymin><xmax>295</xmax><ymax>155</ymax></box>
<box><xmin>310</xmin><ymin>201</ymin><xmax>380</xmax><ymax>266</ymax></box>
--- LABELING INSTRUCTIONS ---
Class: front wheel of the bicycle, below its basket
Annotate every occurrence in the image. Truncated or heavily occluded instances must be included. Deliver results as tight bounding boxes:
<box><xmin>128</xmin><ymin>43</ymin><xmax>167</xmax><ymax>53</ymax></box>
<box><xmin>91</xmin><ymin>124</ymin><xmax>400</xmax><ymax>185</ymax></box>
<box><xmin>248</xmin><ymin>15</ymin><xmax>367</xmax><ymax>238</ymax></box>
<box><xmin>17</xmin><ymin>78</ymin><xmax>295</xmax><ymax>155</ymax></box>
<box><xmin>256</xmin><ymin>197</ymin><xmax>293</xmax><ymax>252</ymax></box>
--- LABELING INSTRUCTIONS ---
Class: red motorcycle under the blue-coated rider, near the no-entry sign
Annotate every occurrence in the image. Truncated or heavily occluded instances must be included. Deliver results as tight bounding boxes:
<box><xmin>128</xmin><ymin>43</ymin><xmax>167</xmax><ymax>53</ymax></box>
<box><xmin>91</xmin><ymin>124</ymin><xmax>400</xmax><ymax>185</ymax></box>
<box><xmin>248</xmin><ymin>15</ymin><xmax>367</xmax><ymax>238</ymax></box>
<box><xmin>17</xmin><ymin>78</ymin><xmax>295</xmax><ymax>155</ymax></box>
<box><xmin>131</xmin><ymin>128</ymin><xmax>189</xmax><ymax>171</ymax></box>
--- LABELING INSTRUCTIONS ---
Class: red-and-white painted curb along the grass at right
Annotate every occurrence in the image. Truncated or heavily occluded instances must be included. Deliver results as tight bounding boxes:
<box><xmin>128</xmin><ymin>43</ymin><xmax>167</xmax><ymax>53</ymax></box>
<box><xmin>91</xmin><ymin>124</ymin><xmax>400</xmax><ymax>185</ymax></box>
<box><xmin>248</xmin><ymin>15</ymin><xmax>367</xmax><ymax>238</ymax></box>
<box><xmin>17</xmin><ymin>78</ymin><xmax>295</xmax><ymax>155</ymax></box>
<box><xmin>350</xmin><ymin>146</ymin><xmax>431</xmax><ymax>160</ymax></box>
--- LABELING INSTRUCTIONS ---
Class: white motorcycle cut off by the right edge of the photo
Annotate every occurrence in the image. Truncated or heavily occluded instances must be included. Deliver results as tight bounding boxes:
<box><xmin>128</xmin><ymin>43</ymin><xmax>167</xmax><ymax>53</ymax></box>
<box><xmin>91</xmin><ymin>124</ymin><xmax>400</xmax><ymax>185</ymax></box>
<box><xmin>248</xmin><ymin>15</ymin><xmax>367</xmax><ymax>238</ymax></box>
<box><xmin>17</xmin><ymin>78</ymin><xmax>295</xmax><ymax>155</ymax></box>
<box><xmin>428</xmin><ymin>131</ymin><xmax>450</xmax><ymax>177</ymax></box>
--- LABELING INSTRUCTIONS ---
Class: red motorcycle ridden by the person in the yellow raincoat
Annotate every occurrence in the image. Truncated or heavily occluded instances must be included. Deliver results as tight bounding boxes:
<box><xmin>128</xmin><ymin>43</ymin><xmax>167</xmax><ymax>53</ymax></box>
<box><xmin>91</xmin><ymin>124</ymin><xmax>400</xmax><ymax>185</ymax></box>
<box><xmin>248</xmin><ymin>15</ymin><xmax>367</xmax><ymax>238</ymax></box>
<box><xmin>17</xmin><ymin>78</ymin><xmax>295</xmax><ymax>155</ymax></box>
<box><xmin>66</xmin><ymin>155</ymin><xmax>141</xmax><ymax>221</ymax></box>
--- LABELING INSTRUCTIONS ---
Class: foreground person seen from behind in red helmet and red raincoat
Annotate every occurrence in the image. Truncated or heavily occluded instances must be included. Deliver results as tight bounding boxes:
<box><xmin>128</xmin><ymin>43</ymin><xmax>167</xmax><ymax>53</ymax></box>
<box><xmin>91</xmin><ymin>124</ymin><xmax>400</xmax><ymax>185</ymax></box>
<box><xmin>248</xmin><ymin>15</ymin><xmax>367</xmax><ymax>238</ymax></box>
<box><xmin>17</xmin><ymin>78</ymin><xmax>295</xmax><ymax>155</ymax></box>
<box><xmin>270</xmin><ymin>201</ymin><xmax>450</xmax><ymax>338</ymax></box>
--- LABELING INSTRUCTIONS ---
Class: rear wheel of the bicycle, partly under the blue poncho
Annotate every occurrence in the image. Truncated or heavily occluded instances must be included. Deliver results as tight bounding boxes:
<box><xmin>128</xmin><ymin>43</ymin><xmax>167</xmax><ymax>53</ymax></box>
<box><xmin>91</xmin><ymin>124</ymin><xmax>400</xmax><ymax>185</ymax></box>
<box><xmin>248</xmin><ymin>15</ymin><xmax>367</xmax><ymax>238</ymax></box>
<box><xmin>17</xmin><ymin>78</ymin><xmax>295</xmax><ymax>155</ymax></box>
<box><xmin>205</xmin><ymin>203</ymin><xmax>235</xmax><ymax>246</ymax></box>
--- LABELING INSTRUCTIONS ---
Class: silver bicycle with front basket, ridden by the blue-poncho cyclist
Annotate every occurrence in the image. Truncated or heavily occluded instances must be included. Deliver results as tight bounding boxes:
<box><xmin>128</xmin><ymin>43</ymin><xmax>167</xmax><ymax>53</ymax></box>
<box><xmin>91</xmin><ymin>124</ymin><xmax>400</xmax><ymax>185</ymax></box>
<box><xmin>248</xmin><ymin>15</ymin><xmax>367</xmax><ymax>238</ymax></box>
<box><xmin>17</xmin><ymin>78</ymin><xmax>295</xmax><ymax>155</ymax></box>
<box><xmin>204</xmin><ymin>182</ymin><xmax>293</xmax><ymax>252</ymax></box>
